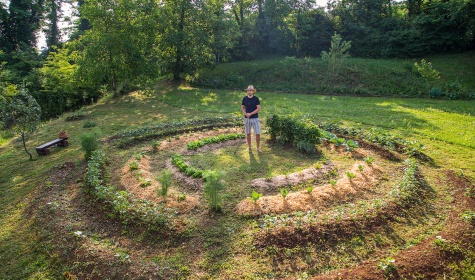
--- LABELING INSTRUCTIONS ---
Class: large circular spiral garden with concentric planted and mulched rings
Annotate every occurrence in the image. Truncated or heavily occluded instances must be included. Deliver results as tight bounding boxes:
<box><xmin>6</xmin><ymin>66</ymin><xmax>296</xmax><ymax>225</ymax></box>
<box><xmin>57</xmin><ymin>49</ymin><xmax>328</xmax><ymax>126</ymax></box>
<box><xmin>33</xmin><ymin>116</ymin><xmax>475</xmax><ymax>279</ymax></box>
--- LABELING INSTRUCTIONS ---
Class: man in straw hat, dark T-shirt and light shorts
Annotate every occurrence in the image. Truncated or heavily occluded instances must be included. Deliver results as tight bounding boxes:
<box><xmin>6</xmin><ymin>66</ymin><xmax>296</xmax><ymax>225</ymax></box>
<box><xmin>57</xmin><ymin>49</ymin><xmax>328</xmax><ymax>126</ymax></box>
<box><xmin>241</xmin><ymin>85</ymin><xmax>262</xmax><ymax>152</ymax></box>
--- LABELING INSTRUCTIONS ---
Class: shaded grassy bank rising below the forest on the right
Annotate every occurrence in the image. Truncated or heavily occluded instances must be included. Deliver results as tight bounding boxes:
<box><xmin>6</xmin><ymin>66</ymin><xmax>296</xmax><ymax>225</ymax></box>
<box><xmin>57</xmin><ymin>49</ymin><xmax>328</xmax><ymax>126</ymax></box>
<box><xmin>187</xmin><ymin>51</ymin><xmax>475</xmax><ymax>98</ymax></box>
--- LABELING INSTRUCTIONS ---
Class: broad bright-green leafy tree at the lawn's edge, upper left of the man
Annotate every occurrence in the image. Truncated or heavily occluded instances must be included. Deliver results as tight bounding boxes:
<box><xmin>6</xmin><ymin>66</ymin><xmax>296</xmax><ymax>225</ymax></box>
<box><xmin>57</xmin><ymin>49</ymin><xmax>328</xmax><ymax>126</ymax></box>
<box><xmin>78</xmin><ymin>0</ymin><xmax>159</xmax><ymax>96</ymax></box>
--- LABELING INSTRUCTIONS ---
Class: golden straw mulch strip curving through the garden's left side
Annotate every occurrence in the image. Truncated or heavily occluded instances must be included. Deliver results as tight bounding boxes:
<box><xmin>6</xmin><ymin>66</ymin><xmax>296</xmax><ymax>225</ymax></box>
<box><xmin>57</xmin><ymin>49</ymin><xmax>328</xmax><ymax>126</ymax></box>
<box><xmin>120</xmin><ymin>155</ymin><xmax>199</xmax><ymax>213</ymax></box>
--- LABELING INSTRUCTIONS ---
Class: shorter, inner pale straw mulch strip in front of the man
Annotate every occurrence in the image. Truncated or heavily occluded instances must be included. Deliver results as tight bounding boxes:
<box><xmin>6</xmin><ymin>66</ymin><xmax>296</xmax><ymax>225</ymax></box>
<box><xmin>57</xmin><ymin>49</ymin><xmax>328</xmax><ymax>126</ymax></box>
<box><xmin>251</xmin><ymin>162</ymin><xmax>334</xmax><ymax>191</ymax></box>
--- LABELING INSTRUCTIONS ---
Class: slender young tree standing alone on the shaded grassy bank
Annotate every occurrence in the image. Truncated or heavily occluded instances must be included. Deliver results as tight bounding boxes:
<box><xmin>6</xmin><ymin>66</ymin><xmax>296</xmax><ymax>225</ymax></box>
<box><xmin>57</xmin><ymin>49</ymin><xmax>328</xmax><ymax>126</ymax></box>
<box><xmin>321</xmin><ymin>32</ymin><xmax>351</xmax><ymax>100</ymax></box>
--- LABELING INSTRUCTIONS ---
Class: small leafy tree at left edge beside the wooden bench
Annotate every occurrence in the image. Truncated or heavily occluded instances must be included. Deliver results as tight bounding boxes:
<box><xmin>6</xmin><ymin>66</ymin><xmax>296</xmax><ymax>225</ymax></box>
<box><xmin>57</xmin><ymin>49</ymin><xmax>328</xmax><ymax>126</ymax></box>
<box><xmin>0</xmin><ymin>84</ymin><xmax>41</xmax><ymax>160</ymax></box>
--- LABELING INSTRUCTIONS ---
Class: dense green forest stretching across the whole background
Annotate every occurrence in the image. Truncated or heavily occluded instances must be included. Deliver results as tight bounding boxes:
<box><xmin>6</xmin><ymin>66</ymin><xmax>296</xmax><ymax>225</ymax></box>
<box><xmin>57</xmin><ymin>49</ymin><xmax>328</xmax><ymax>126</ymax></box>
<box><xmin>0</xmin><ymin>0</ymin><xmax>475</xmax><ymax>119</ymax></box>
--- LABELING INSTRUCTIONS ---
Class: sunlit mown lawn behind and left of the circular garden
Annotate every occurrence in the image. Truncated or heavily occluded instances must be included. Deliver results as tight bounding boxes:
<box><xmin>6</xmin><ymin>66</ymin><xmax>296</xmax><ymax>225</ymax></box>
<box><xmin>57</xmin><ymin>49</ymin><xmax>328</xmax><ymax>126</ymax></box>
<box><xmin>0</xmin><ymin>81</ymin><xmax>475</xmax><ymax>279</ymax></box>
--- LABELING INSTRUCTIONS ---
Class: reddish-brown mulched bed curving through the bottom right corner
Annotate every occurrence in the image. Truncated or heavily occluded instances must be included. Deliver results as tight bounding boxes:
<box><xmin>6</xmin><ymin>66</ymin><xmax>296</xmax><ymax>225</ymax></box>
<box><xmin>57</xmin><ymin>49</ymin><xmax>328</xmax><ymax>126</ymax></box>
<box><xmin>311</xmin><ymin>170</ymin><xmax>475</xmax><ymax>280</ymax></box>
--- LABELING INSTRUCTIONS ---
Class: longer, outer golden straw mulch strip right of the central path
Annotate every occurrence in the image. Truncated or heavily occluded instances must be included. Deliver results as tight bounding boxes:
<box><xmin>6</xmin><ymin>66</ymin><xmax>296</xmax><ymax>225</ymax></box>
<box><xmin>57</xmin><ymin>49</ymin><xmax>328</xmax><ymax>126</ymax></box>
<box><xmin>235</xmin><ymin>162</ymin><xmax>383</xmax><ymax>215</ymax></box>
